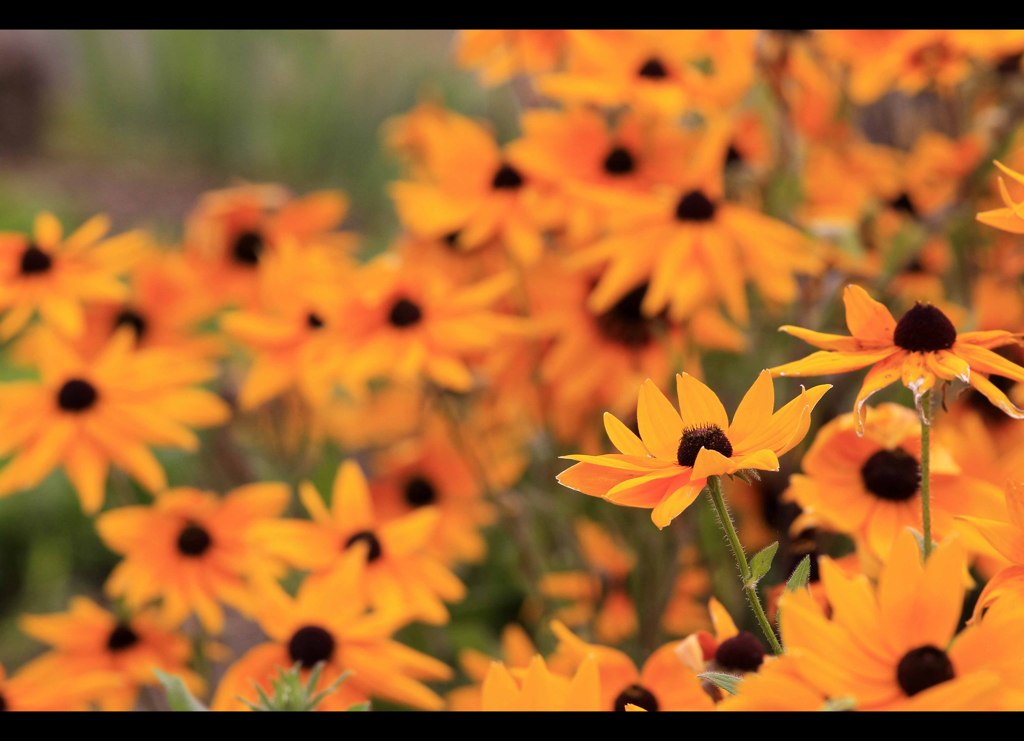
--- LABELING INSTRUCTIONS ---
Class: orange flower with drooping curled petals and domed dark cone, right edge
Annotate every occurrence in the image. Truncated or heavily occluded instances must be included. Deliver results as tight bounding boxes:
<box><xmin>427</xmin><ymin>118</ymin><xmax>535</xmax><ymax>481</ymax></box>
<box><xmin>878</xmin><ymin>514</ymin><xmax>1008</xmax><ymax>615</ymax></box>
<box><xmin>771</xmin><ymin>286</ymin><xmax>1024</xmax><ymax>433</ymax></box>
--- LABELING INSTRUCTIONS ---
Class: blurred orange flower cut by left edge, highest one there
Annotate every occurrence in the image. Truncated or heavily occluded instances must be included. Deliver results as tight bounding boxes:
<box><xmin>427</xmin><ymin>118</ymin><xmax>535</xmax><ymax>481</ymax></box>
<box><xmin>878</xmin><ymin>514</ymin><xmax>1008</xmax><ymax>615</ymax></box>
<box><xmin>0</xmin><ymin>212</ymin><xmax>144</xmax><ymax>340</ymax></box>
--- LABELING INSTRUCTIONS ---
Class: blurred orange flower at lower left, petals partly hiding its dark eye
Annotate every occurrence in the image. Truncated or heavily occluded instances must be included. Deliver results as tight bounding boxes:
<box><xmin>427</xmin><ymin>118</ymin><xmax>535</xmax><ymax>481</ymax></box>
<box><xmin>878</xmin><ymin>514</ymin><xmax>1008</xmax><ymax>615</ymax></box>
<box><xmin>254</xmin><ymin>461</ymin><xmax>466</xmax><ymax>625</ymax></box>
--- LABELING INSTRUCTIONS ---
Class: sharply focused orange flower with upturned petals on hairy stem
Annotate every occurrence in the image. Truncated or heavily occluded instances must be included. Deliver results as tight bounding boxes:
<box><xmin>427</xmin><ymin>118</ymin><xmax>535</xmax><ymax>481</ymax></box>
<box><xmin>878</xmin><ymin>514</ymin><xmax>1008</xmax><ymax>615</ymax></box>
<box><xmin>558</xmin><ymin>371</ymin><xmax>831</xmax><ymax>528</ymax></box>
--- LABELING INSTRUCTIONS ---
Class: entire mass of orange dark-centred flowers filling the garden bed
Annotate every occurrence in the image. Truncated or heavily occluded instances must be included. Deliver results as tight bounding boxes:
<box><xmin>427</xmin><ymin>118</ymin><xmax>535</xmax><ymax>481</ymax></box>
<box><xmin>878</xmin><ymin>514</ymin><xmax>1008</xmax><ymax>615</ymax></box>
<box><xmin>0</xmin><ymin>31</ymin><xmax>1024</xmax><ymax>710</ymax></box>
